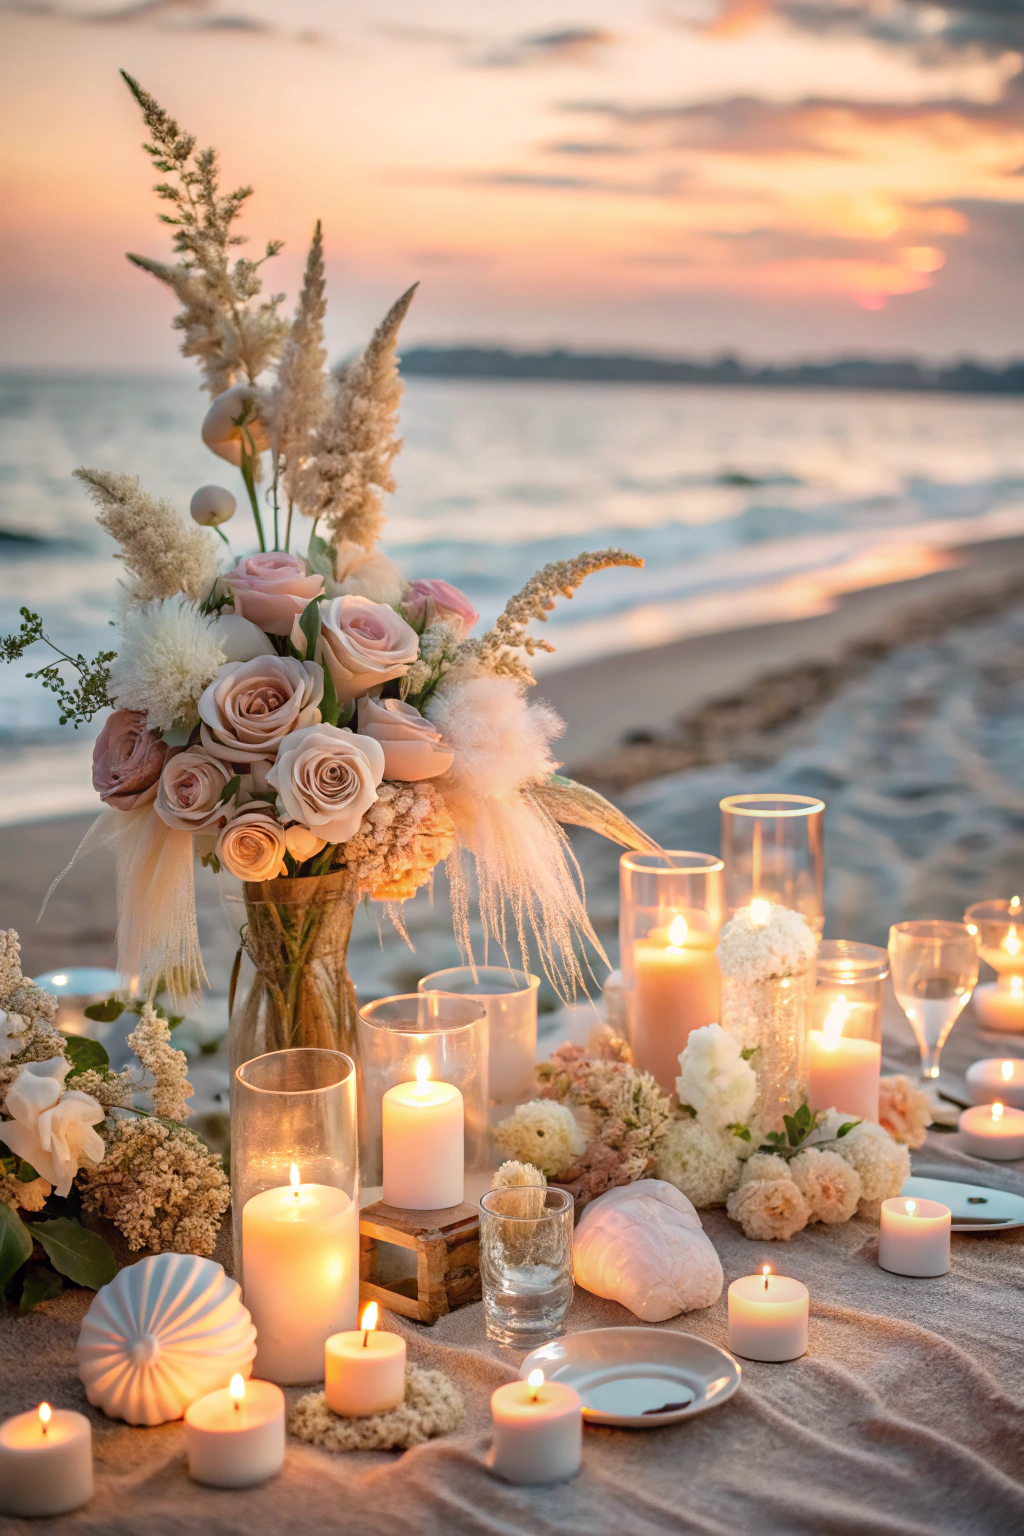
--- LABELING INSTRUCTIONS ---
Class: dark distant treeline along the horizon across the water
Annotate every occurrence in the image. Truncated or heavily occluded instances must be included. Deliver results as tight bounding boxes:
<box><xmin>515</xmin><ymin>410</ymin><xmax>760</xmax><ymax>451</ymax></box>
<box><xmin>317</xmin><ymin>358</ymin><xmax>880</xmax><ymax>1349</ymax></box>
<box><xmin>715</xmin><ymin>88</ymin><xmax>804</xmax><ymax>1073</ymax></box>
<box><xmin>402</xmin><ymin>347</ymin><xmax>1024</xmax><ymax>395</ymax></box>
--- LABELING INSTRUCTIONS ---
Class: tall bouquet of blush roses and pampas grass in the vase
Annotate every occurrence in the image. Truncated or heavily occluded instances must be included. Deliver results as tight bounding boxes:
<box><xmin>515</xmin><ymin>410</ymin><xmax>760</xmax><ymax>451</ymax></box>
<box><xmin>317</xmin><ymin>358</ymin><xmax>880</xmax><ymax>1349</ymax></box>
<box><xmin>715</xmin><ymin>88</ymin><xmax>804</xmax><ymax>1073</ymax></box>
<box><xmin>3</xmin><ymin>75</ymin><xmax>656</xmax><ymax>1013</ymax></box>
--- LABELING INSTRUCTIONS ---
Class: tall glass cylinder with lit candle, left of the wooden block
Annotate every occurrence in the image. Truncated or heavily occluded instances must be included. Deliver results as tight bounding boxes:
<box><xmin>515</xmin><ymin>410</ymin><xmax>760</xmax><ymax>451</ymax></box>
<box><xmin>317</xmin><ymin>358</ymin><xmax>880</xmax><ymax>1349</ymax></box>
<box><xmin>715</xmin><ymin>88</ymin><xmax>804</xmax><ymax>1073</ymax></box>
<box><xmin>232</xmin><ymin>1049</ymin><xmax>359</xmax><ymax>1385</ymax></box>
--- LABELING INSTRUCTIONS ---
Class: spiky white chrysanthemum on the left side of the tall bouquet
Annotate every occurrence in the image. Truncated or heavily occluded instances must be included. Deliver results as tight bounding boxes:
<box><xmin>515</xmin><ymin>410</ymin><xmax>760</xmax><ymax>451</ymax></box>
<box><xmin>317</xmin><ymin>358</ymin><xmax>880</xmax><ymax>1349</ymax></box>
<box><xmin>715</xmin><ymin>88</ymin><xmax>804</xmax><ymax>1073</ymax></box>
<box><xmin>111</xmin><ymin>596</ymin><xmax>227</xmax><ymax>731</ymax></box>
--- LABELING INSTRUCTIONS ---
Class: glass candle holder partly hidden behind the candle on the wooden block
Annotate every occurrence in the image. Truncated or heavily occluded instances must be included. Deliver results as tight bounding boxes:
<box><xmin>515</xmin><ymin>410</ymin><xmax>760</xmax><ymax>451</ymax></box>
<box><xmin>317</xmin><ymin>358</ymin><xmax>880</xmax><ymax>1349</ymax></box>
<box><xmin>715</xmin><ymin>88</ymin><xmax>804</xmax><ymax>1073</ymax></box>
<box><xmin>418</xmin><ymin>965</ymin><xmax>540</xmax><ymax>1118</ymax></box>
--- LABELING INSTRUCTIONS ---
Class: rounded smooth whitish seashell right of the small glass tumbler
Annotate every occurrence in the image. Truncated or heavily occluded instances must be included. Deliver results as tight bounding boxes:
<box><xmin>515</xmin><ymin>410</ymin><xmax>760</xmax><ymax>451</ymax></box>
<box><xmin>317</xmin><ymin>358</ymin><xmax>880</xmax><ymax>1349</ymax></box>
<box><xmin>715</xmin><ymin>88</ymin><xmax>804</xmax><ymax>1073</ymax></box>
<box><xmin>573</xmin><ymin>1178</ymin><xmax>723</xmax><ymax>1322</ymax></box>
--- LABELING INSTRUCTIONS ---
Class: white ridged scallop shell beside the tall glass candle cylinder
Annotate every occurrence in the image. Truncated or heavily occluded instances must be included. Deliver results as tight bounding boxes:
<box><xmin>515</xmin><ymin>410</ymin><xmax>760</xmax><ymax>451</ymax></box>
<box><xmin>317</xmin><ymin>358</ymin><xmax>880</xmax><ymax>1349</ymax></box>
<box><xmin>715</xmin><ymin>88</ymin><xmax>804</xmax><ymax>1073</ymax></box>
<box><xmin>78</xmin><ymin>1253</ymin><xmax>256</xmax><ymax>1424</ymax></box>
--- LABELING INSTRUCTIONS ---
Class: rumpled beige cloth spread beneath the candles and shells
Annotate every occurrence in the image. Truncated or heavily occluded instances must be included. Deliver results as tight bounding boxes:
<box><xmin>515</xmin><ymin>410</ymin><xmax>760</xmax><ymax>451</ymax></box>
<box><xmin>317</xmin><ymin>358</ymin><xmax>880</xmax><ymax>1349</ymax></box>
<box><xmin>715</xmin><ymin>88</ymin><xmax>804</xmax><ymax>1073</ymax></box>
<box><xmin>0</xmin><ymin>1021</ymin><xmax>1024</xmax><ymax>1536</ymax></box>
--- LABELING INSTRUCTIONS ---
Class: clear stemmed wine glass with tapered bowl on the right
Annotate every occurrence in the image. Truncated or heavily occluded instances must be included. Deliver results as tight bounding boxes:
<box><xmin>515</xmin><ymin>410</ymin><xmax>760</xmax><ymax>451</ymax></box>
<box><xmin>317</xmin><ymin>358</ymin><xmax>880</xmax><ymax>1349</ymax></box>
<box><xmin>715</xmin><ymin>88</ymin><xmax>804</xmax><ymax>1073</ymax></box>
<box><xmin>889</xmin><ymin>920</ymin><xmax>978</xmax><ymax>1080</ymax></box>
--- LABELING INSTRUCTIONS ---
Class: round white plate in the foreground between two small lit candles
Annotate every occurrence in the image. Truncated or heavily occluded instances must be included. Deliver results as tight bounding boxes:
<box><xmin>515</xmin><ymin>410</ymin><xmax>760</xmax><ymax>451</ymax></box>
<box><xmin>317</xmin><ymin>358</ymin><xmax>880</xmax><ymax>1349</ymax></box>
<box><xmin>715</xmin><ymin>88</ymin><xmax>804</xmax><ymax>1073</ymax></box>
<box><xmin>519</xmin><ymin>1329</ymin><xmax>740</xmax><ymax>1430</ymax></box>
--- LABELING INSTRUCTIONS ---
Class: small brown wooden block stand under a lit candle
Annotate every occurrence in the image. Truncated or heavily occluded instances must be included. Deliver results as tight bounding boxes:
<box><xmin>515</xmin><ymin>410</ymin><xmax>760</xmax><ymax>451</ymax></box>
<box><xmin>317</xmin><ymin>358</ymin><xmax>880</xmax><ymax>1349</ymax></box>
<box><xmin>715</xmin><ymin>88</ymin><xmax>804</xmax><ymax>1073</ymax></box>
<box><xmin>359</xmin><ymin>1200</ymin><xmax>481</xmax><ymax>1322</ymax></box>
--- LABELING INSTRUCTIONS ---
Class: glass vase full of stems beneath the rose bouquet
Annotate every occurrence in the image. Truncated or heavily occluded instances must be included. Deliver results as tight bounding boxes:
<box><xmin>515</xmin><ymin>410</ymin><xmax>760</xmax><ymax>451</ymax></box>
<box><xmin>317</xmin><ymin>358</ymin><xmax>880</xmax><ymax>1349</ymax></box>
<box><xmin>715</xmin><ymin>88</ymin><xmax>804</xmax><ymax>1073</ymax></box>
<box><xmin>221</xmin><ymin>869</ymin><xmax>358</xmax><ymax>1072</ymax></box>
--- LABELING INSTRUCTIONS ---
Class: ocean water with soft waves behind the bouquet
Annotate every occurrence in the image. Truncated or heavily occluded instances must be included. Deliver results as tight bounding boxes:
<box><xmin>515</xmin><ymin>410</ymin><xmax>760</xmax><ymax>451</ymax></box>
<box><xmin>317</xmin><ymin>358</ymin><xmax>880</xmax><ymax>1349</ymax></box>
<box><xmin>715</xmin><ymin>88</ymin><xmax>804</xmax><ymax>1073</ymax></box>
<box><xmin>0</xmin><ymin>375</ymin><xmax>1024</xmax><ymax>822</ymax></box>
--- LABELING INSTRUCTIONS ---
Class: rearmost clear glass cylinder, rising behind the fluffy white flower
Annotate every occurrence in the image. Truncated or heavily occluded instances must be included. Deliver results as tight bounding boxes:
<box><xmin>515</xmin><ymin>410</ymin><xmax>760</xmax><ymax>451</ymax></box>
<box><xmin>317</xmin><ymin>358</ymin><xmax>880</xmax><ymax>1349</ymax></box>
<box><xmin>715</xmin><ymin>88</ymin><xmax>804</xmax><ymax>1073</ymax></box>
<box><xmin>718</xmin><ymin>794</ymin><xmax>824</xmax><ymax>938</ymax></box>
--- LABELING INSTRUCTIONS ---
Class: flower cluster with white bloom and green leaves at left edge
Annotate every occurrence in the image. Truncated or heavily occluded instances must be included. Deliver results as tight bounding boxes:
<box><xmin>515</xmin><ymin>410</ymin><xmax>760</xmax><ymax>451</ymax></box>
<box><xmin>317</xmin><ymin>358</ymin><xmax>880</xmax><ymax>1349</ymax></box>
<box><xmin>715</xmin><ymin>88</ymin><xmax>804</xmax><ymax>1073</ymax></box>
<box><xmin>0</xmin><ymin>928</ymin><xmax>230</xmax><ymax>1312</ymax></box>
